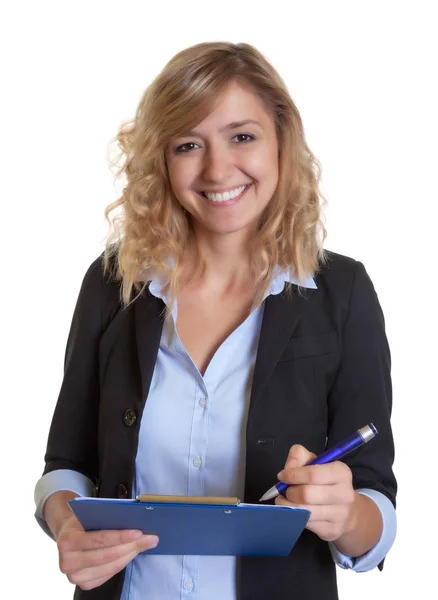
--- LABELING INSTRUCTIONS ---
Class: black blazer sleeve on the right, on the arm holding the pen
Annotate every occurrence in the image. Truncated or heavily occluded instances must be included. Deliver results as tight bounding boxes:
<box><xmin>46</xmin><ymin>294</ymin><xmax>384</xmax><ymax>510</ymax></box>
<box><xmin>327</xmin><ymin>262</ymin><xmax>397</xmax><ymax>507</ymax></box>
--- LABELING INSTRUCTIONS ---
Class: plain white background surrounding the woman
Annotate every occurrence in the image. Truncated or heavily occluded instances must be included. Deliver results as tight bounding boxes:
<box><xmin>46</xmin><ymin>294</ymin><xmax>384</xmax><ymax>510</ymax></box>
<box><xmin>0</xmin><ymin>0</ymin><xmax>438</xmax><ymax>600</ymax></box>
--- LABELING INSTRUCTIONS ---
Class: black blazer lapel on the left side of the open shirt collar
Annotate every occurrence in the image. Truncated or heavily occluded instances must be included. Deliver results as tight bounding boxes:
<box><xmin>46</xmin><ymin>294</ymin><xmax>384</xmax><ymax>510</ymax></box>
<box><xmin>134</xmin><ymin>290</ymin><xmax>165</xmax><ymax>402</ymax></box>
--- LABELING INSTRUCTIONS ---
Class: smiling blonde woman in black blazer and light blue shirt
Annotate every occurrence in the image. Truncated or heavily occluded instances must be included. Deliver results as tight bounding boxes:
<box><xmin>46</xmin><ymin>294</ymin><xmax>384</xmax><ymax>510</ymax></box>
<box><xmin>36</xmin><ymin>43</ymin><xmax>396</xmax><ymax>600</ymax></box>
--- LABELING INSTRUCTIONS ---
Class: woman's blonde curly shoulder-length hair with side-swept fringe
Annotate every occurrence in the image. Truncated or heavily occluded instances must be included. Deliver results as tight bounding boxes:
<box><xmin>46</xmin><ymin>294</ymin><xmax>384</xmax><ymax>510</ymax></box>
<box><xmin>105</xmin><ymin>42</ymin><xmax>326</xmax><ymax>308</ymax></box>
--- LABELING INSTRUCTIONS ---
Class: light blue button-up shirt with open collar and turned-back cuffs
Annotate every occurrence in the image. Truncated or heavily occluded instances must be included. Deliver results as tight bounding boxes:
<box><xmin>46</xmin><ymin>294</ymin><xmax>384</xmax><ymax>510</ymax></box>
<box><xmin>35</xmin><ymin>269</ymin><xmax>396</xmax><ymax>600</ymax></box>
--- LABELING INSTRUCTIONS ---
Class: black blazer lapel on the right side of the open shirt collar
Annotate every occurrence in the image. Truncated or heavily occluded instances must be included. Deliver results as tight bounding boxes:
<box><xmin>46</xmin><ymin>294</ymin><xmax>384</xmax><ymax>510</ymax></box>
<box><xmin>249</xmin><ymin>285</ymin><xmax>307</xmax><ymax>416</ymax></box>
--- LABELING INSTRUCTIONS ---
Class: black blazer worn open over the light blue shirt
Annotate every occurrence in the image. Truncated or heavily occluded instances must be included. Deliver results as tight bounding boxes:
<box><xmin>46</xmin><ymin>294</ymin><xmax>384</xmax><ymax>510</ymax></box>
<box><xmin>44</xmin><ymin>252</ymin><xmax>396</xmax><ymax>600</ymax></box>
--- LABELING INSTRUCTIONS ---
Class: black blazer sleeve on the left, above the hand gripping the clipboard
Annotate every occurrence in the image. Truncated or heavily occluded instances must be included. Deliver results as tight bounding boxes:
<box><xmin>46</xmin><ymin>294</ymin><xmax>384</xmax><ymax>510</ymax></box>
<box><xmin>44</xmin><ymin>257</ymin><xmax>117</xmax><ymax>484</ymax></box>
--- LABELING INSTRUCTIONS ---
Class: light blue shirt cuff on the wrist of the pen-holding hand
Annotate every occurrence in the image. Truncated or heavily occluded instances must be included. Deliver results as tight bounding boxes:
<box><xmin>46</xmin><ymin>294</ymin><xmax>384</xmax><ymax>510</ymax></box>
<box><xmin>329</xmin><ymin>489</ymin><xmax>397</xmax><ymax>573</ymax></box>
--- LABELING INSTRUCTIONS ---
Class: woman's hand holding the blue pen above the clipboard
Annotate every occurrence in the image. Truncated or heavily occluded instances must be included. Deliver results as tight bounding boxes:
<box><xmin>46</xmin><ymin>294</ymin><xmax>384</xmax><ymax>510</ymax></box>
<box><xmin>275</xmin><ymin>444</ymin><xmax>358</xmax><ymax>542</ymax></box>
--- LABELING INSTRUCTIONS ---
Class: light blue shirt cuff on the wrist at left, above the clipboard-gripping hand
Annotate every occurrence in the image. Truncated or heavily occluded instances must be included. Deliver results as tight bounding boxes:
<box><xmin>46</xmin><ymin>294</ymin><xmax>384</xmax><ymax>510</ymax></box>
<box><xmin>34</xmin><ymin>469</ymin><xmax>95</xmax><ymax>539</ymax></box>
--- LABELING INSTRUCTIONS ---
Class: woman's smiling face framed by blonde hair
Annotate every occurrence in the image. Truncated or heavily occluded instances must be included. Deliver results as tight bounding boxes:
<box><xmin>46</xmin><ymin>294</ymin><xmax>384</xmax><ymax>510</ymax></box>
<box><xmin>166</xmin><ymin>82</ymin><xmax>278</xmax><ymax>241</ymax></box>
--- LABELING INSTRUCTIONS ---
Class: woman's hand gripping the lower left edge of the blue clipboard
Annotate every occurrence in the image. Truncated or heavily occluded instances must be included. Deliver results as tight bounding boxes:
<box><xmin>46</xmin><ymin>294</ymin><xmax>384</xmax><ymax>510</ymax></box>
<box><xmin>57</xmin><ymin>515</ymin><xmax>158</xmax><ymax>590</ymax></box>
